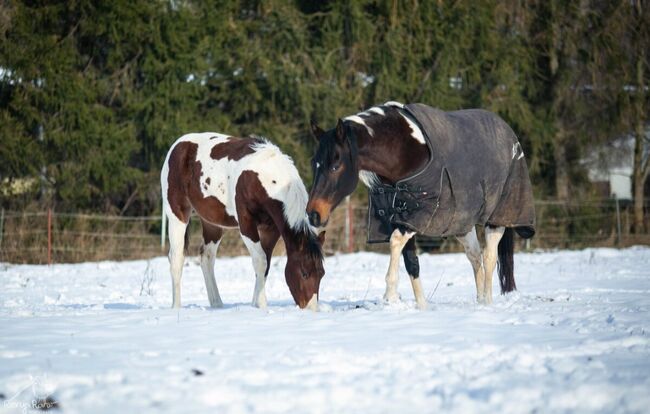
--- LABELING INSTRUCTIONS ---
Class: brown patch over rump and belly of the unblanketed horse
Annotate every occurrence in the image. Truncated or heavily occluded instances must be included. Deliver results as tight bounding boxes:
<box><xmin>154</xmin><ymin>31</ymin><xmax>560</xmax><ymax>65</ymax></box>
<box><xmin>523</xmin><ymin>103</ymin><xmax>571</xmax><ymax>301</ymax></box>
<box><xmin>167</xmin><ymin>141</ymin><xmax>237</xmax><ymax>227</ymax></box>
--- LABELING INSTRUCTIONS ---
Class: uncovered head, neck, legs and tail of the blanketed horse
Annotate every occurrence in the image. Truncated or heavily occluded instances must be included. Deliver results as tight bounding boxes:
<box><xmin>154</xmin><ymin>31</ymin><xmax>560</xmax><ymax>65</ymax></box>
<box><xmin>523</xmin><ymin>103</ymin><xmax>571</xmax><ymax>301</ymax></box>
<box><xmin>307</xmin><ymin>102</ymin><xmax>523</xmax><ymax>309</ymax></box>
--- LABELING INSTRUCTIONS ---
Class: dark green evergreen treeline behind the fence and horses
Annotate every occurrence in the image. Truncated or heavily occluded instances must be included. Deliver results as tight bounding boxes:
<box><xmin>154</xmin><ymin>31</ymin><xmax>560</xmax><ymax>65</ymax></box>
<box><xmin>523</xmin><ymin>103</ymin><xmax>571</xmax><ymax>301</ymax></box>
<box><xmin>0</xmin><ymin>0</ymin><xmax>650</xmax><ymax>228</ymax></box>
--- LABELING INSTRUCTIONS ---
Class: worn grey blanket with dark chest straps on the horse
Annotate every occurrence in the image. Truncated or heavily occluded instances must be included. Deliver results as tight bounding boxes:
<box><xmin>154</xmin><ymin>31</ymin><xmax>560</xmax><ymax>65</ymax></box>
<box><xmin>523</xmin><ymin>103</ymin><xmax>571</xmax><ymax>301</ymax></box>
<box><xmin>368</xmin><ymin>104</ymin><xmax>535</xmax><ymax>243</ymax></box>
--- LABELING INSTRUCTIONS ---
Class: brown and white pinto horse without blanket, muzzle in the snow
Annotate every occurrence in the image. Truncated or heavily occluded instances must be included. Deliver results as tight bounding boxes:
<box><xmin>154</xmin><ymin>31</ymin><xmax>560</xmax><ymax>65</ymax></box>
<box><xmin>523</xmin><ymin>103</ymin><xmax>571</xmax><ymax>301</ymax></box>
<box><xmin>160</xmin><ymin>132</ymin><xmax>324</xmax><ymax>310</ymax></box>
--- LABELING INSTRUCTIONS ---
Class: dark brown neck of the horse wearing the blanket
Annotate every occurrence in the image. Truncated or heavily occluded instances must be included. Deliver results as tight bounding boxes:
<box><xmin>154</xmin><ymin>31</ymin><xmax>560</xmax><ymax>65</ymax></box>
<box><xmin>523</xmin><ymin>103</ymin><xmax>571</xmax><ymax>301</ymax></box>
<box><xmin>355</xmin><ymin>120</ymin><xmax>429</xmax><ymax>183</ymax></box>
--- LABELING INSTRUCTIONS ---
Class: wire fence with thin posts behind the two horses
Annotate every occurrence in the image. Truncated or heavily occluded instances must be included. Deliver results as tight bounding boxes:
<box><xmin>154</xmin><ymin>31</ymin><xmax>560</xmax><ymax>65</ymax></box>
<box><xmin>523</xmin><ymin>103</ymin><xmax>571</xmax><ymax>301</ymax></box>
<box><xmin>0</xmin><ymin>199</ymin><xmax>650</xmax><ymax>263</ymax></box>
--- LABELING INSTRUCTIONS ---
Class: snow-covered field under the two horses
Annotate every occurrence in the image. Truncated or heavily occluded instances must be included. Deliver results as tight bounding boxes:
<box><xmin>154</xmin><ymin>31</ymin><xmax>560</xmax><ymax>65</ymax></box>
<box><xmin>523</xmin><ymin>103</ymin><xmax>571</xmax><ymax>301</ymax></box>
<box><xmin>0</xmin><ymin>247</ymin><xmax>650</xmax><ymax>414</ymax></box>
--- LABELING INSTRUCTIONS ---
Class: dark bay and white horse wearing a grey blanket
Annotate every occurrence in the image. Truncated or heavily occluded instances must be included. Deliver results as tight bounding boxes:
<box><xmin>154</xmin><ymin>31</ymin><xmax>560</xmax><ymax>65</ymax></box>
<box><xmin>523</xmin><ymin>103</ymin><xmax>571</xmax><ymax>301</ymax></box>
<box><xmin>307</xmin><ymin>102</ymin><xmax>535</xmax><ymax>309</ymax></box>
